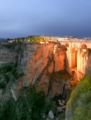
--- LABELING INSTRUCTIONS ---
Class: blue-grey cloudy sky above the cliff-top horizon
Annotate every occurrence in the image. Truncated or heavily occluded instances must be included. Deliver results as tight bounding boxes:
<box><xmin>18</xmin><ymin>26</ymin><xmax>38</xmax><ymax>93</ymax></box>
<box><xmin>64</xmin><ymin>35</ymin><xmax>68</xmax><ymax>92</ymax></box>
<box><xmin>0</xmin><ymin>0</ymin><xmax>91</xmax><ymax>38</ymax></box>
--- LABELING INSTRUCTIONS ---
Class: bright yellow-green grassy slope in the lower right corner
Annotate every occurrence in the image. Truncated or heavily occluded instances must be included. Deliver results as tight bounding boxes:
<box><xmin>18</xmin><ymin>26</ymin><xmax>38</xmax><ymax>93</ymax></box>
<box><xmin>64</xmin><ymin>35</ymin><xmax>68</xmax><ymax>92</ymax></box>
<box><xmin>66</xmin><ymin>76</ymin><xmax>91</xmax><ymax>120</ymax></box>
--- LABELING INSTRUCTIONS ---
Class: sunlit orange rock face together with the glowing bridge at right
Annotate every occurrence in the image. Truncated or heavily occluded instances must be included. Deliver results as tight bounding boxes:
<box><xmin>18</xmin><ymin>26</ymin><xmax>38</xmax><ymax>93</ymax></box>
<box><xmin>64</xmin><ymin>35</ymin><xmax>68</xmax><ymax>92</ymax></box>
<box><xmin>25</xmin><ymin>39</ymin><xmax>91</xmax><ymax>95</ymax></box>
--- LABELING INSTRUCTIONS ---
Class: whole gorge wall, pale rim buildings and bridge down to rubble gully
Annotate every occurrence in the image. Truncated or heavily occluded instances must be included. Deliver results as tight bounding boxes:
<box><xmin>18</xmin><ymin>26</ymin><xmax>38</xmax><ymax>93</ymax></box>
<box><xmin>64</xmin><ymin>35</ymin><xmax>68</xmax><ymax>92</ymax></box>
<box><xmin>0</xmin><ymin>36</ymin><xmax>91</xmax><ymax>120</ymax></box>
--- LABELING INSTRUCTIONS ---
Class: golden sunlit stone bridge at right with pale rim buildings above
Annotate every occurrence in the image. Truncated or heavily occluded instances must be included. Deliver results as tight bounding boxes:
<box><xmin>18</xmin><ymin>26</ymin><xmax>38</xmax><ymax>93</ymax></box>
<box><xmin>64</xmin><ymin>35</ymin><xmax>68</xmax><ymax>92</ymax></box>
<box><xmin>45</xmin><ymin>37</ymin><xmax>91</xmax><ymax>79</ymax></box>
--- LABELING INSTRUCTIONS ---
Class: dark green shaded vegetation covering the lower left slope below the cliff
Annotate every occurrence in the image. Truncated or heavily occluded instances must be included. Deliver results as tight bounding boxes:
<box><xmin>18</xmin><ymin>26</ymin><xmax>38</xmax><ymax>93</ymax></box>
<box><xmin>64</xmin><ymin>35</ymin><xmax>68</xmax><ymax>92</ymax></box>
<box><xmin>0</xmin><ymin>64</ymin><xmax>55</xmax><ymax>120</ymax></box>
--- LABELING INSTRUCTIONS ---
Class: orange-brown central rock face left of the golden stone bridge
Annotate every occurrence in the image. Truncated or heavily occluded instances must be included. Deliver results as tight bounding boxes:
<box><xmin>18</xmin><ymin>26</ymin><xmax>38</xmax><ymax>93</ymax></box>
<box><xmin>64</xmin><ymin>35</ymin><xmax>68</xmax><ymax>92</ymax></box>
<box><xmin>26</xmin><ymin>43</ymin><xmax>70</xmax><ymax>96</ymax></box>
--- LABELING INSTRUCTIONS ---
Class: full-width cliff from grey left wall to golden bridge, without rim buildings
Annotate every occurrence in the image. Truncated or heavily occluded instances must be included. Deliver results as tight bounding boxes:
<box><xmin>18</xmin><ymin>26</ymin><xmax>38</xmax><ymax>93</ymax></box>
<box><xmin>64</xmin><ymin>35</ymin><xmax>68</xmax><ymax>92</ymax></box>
<box><xmin>0</xmin><ymin>41</ymin><xmax>91</xmax><ymax>95</ymax></box>
